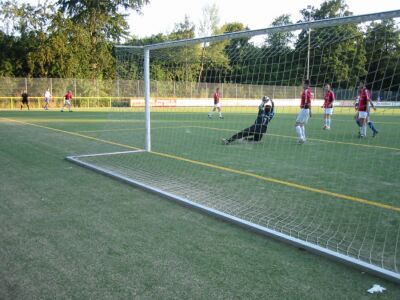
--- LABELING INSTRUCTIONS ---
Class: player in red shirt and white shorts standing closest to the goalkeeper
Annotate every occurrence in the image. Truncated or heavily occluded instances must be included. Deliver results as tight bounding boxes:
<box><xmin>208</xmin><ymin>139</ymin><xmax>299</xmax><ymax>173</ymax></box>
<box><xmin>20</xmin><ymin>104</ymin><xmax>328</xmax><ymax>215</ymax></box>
<box><xmin>295</xmin><ymin>79</ymin><xmax>312</xmax><ymax>144</ymax></box>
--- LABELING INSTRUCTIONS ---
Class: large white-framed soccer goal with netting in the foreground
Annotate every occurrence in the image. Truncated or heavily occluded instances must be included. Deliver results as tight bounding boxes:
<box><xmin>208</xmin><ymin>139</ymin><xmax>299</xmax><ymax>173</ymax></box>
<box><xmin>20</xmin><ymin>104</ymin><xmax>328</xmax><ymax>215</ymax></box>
<box><xmin>68</xmin><ymin>10</ymin><xmax>400</xmax><ymax>282</ymax></box>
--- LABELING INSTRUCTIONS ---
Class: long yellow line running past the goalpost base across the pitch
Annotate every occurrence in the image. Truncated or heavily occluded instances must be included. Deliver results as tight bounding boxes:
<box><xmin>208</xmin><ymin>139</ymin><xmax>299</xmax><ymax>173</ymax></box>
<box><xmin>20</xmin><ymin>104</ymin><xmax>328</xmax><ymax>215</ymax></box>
<box><xmin>3</xmin><ymin>118</ymin><xmax>400</xmax><ymax>212</ymax></box>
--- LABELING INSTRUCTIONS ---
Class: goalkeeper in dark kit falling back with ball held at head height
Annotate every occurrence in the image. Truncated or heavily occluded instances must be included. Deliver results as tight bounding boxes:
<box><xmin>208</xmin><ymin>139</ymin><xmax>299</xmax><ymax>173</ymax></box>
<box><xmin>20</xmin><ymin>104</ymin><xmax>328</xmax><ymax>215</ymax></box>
<box><xmin>222</xmin><ymin>96</ymin><xmax>275</xmax><ymax>145</ymax></box>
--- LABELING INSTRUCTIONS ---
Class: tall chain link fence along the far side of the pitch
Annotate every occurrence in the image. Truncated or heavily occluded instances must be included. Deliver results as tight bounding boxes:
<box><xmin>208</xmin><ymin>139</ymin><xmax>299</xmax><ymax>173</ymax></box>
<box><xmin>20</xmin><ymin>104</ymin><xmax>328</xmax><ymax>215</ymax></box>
<box><xmin>0</xmin><ymin>77</ymin><xmax>394</xmax><ymax>109</ymax></box>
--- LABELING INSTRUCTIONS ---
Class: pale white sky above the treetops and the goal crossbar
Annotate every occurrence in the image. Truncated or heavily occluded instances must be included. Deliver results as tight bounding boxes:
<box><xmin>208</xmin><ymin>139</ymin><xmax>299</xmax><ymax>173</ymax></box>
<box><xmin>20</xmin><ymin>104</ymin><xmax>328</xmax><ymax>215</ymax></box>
<box><xmin>128</xmin><ymin>0</ymin><xmax>400</xmax><ymax>38</ymax></box>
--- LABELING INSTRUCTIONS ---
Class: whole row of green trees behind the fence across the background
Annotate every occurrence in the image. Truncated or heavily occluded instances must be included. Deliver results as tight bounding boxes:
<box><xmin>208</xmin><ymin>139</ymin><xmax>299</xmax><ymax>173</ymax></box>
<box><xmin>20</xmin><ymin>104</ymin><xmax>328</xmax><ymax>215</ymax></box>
<box><xmin>0</xmin><ymin>0</ymin><xmax>400</xmax><ymax>90</ymax></box>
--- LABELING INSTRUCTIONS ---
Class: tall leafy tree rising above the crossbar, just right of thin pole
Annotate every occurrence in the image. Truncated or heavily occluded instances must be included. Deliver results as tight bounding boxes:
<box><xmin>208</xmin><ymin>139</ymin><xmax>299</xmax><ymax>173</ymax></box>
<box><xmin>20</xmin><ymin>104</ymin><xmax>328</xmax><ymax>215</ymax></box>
<box><xmin>296</xmin><ymin>0</ymin><xmax>366</xmax><ymax>88</ymax></box>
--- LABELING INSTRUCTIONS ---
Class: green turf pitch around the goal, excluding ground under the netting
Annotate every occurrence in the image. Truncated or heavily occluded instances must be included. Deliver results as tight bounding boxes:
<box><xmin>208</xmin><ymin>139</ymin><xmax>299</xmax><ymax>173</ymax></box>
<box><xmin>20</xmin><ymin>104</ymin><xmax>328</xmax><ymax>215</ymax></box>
<box><xmin>0</xmin><ymin>109</ymin><xmax>400</xmax><ymax>299</ymax></box>
